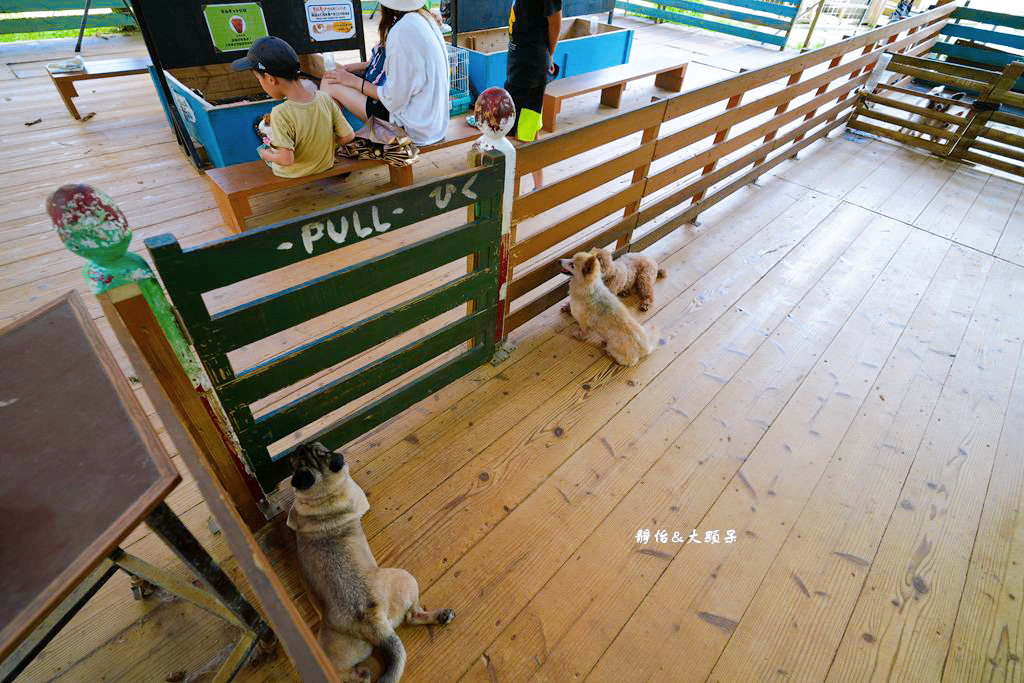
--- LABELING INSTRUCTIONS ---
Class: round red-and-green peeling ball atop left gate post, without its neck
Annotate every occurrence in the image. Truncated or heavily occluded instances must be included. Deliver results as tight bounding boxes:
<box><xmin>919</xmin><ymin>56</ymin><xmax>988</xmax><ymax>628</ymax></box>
<box><xmin>46</xmin><ymin>183</ymin><xmax>131</xmax><ymax>263</ymax></box>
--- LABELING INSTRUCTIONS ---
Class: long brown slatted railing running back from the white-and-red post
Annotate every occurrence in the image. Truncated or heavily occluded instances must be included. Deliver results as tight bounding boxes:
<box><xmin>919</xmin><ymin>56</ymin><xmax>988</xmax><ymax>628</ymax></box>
<box><xmin>505</xmin><ymin>5</ymin><xmax>955</xmax><ymax>332</ymax></box>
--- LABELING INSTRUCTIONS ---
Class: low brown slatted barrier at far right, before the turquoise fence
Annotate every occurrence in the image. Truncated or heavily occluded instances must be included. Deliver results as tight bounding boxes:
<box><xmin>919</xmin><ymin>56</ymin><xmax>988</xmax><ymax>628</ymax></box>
<box><xmin>848</xmin><ymin>55</ymin><xmax>1024</xmax><ymax>176</ymax></box>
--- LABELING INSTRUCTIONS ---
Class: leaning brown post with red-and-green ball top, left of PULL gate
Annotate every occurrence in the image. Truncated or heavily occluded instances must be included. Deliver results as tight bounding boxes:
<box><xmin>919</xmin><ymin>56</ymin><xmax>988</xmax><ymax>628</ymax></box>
<box><xmin>47</xmin><ymin>184</ymin><xmax>266</xmax><ymax>528</ymax></box>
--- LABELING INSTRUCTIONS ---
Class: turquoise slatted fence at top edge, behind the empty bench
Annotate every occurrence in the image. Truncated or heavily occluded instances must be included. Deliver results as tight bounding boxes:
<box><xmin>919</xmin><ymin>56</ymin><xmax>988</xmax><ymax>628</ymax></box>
<box><xmin>615</xmin><ymin>0</ymin><xmax>800</xmax><ymax>49</ymax></box>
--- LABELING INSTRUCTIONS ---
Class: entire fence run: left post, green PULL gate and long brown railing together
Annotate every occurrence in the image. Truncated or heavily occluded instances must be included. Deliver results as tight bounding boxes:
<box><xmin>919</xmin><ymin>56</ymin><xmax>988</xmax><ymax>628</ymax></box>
<box><xmin>56</xmin><ymin>6</ymin><xmax>962</xmax><ymax>526</ymax></box>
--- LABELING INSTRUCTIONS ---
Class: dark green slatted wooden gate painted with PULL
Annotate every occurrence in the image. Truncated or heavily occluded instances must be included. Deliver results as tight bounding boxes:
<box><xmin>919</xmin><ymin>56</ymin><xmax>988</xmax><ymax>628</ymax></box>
<box><xmin>145</xmin><ymin>165</ymin><xmax>505</xmax><ymax>492</ymax></box>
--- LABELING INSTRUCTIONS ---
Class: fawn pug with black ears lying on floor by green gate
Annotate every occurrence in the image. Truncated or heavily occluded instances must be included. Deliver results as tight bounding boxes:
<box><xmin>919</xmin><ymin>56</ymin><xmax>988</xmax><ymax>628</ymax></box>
<box><xmin>288</xmin><ymin>443</ymin><xmax>455</xmax><ymax>683</ymax></box>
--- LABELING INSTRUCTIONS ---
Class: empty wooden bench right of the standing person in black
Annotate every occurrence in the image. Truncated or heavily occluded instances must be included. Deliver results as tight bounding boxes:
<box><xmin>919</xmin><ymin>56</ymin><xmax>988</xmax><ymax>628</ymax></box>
<box><xmin>543</xmin><ymin>58</ymin><xmax>689</xmax><ymax>133</ymax></box>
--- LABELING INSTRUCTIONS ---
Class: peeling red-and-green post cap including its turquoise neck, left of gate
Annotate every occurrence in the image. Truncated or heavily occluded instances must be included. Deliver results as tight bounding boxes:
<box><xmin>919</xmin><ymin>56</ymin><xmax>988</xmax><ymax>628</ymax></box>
<box><xmin>46</xmin><ymin>183</ymin><xmax>153</xmax><ymax>293</ymax></box>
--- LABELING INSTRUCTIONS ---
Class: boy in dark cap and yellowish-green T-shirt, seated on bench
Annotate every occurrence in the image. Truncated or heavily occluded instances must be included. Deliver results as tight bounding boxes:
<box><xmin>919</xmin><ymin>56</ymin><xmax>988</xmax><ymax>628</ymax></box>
<box><xmin>231</xmin><ymin>36</ymin><xmax>355</xmax><ymax>178</ymax></box>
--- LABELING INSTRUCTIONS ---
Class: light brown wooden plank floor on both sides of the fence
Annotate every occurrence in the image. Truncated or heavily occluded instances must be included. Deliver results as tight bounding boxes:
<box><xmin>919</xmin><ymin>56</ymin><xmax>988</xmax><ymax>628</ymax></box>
<box><xmin>0</xmin><ymin>15</ymin><xmax>1024</xmax><ymax>682</ymax></box>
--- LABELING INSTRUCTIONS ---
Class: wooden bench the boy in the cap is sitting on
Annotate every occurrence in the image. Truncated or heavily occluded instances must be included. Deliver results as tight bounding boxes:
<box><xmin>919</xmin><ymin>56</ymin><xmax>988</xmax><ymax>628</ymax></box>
<box><xmin>206</xmin><ymin>116</ymin><xmax>480</xmax><ymax>232</ymax></box>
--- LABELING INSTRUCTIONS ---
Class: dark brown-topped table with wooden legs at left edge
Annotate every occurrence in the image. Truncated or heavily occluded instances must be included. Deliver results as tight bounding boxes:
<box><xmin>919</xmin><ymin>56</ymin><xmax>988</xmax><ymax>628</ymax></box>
<box><xmin>0</xmin><ymin>293</ymin><xmax>269</xmax><ymax>681</ymax></box>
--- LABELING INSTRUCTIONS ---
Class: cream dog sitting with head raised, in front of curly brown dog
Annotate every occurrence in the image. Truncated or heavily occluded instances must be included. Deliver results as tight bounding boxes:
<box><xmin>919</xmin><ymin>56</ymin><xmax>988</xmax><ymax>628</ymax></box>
<box><xmin>560</xmin><ymin>252</ymin><xmax>657</xmax><ymax>366</ymax></box>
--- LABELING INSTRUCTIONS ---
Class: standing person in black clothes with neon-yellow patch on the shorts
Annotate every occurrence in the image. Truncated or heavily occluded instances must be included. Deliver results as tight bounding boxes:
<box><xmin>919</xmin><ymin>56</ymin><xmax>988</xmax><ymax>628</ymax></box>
<box><xmin>505</xmin><ymin>0</ymin><xmax>562</xmax><ymax>187</ymax></box>
